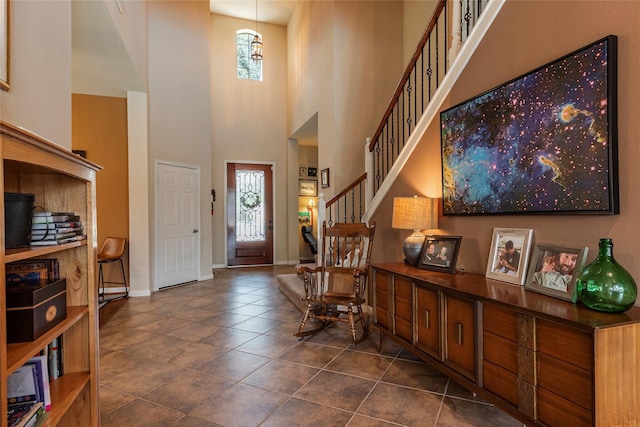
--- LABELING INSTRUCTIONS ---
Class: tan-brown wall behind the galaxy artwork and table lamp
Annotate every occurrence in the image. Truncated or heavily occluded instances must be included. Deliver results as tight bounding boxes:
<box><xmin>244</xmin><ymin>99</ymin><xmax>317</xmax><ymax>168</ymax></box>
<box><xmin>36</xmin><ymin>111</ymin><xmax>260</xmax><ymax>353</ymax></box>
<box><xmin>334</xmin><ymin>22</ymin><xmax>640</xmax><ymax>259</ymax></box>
<box><xmin>374</xmin><ymin>1</ymin><xmax>640</xmax><ymax>300</ymax></box>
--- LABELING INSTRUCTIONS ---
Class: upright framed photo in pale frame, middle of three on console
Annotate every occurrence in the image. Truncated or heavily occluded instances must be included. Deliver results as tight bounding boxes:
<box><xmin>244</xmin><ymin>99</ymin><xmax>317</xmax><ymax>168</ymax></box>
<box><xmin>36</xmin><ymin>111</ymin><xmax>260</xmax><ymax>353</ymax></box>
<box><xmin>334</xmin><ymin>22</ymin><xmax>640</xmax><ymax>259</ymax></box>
<box><xmin>486</xmin><ymin>228</ymin><xmax>533</xmax><ymax>285</ymax></box>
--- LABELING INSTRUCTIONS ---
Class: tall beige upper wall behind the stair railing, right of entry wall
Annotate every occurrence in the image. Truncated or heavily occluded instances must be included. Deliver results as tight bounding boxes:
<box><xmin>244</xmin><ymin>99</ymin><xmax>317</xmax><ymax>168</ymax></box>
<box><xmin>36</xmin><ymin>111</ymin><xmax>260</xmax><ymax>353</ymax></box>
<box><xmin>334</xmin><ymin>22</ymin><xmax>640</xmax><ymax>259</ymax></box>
<box><xmin>288</xmin><ymin>1</ymin><xmax>403</xmax><ymax>197</ymax></box>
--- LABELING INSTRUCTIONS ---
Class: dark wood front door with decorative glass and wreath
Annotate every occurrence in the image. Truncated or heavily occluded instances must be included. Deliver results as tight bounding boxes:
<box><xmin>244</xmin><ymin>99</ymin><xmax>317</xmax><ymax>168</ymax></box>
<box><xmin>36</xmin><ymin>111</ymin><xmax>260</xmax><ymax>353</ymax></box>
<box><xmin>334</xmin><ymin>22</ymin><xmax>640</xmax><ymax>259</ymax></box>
<box><xmin>227</xmin><ymin>163</ymin><xmax>273</xmax><ymax>266</ymax></box>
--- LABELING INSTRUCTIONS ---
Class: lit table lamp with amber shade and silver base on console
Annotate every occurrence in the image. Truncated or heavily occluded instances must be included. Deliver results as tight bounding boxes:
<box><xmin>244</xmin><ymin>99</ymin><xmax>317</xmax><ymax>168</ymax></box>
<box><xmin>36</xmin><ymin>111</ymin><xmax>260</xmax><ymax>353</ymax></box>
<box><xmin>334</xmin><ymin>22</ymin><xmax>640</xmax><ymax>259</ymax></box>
<box><xmin>391</xmin><ymin>196</ymin><xmax>435</xmax><ymax>266</ymax></box>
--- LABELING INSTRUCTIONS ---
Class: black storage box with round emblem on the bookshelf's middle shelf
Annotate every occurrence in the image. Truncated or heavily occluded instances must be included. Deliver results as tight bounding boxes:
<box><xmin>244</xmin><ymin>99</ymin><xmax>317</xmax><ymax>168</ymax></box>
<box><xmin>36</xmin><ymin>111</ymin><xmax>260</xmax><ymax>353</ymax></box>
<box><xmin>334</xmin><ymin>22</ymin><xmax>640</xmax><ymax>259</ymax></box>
<box><xmin>7</xmin><ymin>279</ymin><xmax>67</xmax><ymax>343</ymax></box>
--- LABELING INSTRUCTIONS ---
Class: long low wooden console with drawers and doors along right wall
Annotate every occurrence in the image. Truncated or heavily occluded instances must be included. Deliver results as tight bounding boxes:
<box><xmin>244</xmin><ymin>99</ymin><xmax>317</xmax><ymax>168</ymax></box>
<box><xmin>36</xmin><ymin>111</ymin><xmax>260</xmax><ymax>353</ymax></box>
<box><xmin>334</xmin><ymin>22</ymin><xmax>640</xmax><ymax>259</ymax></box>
<box><xmin>372</xmin><ymin>263</ymin><xmax>640</xmax><ymax>427</ymax></box>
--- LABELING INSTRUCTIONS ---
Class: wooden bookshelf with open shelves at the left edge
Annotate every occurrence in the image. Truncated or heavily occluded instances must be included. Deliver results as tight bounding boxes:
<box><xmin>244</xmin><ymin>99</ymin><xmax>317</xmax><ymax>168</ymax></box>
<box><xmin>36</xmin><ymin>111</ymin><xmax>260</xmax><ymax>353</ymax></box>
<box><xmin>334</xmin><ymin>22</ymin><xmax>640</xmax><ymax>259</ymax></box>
<box><xmin>0</xmin><ymin>121</ymin><xmax>101</xmax><ymax>426</ymax></box>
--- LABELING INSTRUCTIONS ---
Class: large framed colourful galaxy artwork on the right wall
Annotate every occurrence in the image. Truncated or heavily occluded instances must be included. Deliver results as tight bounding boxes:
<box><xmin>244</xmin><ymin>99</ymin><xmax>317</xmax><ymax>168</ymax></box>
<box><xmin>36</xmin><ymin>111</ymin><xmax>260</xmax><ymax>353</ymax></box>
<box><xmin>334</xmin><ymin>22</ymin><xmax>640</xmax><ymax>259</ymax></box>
<box><xmin>440</xmin><ymin>36</ymin><xmax>619</xmax><ymax>215</ymax></box>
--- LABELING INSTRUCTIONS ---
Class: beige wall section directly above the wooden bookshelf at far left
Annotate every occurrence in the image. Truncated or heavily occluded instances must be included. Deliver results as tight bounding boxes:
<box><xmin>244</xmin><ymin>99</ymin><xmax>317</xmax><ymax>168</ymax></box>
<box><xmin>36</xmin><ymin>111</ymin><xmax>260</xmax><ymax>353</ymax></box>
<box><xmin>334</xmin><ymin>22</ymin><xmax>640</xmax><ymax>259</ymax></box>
<box><xmin>0</xmin><ymin>1</ymin><xmax>71</xmax><ymax>148</ymax></box>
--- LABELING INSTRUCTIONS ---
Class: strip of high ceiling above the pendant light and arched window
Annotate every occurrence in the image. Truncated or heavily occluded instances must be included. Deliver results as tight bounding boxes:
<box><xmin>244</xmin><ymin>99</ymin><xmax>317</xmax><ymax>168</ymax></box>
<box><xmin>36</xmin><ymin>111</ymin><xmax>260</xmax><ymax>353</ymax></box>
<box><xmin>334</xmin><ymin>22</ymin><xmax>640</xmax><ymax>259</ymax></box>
<box><xmin>210</xmin><ymin>0</ymin><xmax>298</xmax><ymax>25</ymax></box>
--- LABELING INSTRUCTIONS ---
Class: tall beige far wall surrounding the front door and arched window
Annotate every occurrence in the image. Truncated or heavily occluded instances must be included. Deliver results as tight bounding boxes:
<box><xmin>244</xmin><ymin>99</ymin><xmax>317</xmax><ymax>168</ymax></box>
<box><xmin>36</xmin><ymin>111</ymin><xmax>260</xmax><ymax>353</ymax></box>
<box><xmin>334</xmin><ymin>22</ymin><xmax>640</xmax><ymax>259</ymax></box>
<box><xmin>210</xmin><ymin>15</ymin><xmax>288</xmax><ymax>266</ymax></box>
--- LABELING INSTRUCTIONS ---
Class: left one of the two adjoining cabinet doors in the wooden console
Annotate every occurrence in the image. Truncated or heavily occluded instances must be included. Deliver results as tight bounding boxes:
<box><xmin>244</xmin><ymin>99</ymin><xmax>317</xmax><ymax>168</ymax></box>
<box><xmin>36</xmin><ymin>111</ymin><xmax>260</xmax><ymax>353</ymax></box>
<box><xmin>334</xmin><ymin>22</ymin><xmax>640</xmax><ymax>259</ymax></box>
<box><xmin>415</xmin><ymin>286</ymin><xmax>440</xmax><ymax>359</ymax></box>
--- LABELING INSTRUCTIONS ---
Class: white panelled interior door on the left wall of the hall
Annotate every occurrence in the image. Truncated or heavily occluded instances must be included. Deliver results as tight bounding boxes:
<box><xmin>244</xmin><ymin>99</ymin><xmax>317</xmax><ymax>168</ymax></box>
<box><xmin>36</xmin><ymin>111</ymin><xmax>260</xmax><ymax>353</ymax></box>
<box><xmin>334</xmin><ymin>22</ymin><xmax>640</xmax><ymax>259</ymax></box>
<box><xmin>155</xmin><ymin>163</ymin><xmax>200</xmax><ymax>289</ymax></box>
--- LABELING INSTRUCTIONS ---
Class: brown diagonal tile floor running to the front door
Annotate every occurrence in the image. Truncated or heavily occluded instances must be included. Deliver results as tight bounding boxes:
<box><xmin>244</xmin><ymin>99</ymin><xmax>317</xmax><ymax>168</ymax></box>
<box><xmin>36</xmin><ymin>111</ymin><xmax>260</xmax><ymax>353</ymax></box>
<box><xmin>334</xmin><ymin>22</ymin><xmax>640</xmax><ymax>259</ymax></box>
<box><xmin>100</xmin><ymin>267</ymin><xmax>522</xmax><ymax>427</ymax></box>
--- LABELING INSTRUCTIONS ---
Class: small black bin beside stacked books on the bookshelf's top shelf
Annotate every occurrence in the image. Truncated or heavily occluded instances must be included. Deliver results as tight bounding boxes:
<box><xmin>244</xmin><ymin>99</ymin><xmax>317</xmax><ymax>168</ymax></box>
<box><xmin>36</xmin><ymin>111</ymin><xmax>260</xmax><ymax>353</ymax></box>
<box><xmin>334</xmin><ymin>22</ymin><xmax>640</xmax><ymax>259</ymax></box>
<box><xmin>4</xmin><ymin>193</ymin><xmax>35</xmax><ymax>249</ymax></box>
